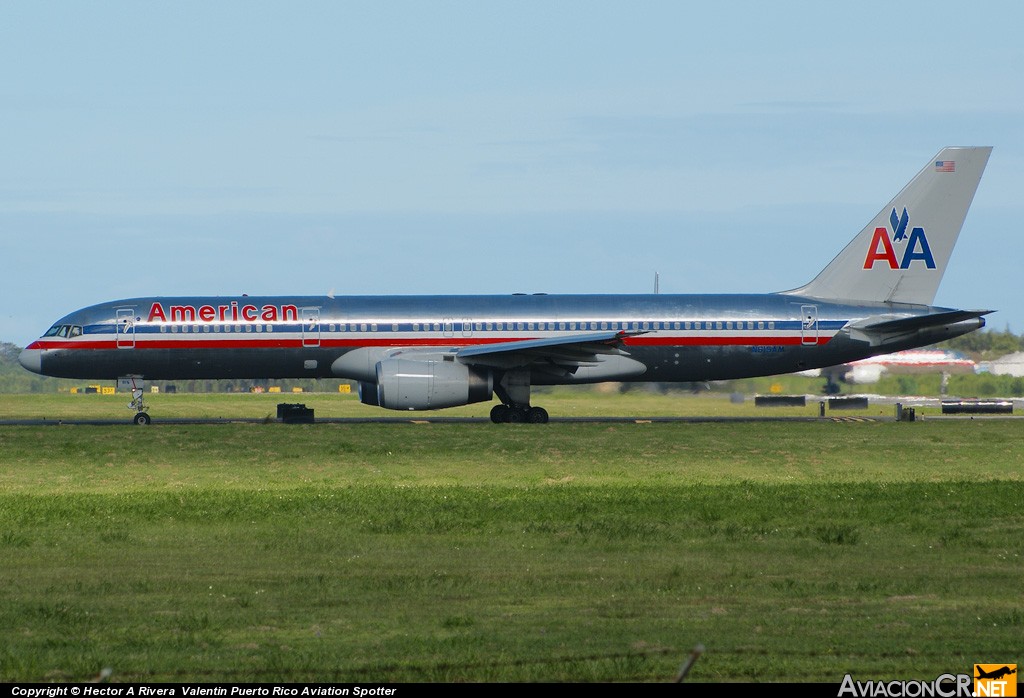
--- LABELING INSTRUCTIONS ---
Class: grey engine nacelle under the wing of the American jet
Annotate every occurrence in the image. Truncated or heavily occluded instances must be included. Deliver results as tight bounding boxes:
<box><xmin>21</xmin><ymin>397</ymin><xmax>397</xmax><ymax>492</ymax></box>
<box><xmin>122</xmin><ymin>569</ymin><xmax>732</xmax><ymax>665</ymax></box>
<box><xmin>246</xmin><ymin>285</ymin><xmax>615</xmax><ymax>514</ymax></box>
<box><xmin>359</xmin><ymin>357</ymin><xmax>495</xmax><ymax>409</ymax></box>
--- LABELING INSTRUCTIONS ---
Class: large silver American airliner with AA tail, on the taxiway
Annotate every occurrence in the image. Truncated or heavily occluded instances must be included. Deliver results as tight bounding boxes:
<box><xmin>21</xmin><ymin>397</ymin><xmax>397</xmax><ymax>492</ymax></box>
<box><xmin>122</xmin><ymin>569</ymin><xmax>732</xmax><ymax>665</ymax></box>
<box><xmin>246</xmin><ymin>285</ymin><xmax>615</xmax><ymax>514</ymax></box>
<box><xmin>19</xmin><ymin>146</ymin><xmax>992</xmax><ymax>424</ymax></box>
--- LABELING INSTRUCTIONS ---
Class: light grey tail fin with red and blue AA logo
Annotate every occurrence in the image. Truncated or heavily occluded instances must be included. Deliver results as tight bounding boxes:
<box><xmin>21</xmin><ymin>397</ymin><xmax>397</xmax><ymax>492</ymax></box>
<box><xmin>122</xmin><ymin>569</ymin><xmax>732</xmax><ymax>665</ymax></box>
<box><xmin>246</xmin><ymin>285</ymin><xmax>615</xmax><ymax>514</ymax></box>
<box><xmin>785</xmin><ymin>146</ymin><xmax>992</xmax><ymax>305</ymax></box>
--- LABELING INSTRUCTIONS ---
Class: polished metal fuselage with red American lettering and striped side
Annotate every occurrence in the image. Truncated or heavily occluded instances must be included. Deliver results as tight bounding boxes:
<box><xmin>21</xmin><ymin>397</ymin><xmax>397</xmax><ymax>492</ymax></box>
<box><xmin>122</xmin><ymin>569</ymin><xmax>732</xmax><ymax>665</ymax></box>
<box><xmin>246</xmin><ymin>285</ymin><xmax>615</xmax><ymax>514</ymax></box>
<box><xmin>22</xmin><ymin>294</ymin><xmax>984</xmax><ymax>385</ymax></box>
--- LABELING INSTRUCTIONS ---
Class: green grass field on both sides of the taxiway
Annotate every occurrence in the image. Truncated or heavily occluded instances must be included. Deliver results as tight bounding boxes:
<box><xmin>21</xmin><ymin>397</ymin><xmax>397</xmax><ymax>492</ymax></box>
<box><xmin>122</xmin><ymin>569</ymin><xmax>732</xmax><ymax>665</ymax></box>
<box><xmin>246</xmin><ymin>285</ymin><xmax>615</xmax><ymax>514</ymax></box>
<box><xmin>0</xmin><ymin>394</ymin><xmax>1024</xmax><ymax>683</ymax></box>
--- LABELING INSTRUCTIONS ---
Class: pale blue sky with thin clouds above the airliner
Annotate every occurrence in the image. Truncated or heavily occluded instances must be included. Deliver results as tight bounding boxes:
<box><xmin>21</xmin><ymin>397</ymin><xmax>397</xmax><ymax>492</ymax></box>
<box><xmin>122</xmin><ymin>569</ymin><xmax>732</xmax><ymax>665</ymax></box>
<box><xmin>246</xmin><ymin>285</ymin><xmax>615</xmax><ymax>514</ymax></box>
<box><xmin>0</xmin><ymin>1</ymin><xmax>1024</xmax><ymax>345</ymax></box>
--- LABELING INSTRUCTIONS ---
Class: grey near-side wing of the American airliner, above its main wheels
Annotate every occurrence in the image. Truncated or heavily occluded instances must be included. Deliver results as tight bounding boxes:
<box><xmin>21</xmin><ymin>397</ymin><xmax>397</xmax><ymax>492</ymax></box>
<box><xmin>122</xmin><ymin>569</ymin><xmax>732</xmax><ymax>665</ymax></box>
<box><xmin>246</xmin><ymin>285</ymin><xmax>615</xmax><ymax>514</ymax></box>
<box><xmin>456</xmin><ymin>331</ymin><xmax>645</xmax><ymax>370</ymax></box>
